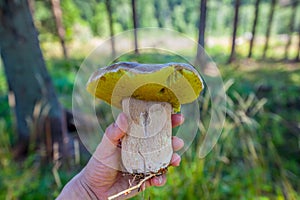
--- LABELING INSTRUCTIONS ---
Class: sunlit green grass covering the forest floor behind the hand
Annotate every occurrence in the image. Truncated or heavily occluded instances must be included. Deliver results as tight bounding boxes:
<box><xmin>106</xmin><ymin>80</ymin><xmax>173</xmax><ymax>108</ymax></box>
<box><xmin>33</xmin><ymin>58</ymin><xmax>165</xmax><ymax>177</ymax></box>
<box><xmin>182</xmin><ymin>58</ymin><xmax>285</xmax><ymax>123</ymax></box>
<box><xmin>0</xmin><ymin>38</ymin><xmax>300</xmax><ymax>199</ymax></box>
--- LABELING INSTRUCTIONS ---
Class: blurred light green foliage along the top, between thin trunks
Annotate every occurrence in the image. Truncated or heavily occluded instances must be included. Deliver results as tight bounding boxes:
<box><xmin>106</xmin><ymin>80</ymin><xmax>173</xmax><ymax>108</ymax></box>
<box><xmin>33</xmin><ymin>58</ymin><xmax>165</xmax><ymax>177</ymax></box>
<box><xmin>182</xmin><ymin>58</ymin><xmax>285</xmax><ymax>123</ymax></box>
<box><xmin>34</xmin><ymin>0</ymin><xmax>300</xmax><ymax>45</ymax></box>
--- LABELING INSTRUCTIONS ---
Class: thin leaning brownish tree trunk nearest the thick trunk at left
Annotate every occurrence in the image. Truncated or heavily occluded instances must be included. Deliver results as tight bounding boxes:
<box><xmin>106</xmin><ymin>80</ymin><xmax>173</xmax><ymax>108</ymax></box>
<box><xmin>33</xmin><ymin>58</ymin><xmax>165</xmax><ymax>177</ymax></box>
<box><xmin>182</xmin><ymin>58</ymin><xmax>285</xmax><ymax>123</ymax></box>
<box><xmin>51</xmin><ymin>0</ymin><xmax>68</xmax><ymax>58</ymax></box>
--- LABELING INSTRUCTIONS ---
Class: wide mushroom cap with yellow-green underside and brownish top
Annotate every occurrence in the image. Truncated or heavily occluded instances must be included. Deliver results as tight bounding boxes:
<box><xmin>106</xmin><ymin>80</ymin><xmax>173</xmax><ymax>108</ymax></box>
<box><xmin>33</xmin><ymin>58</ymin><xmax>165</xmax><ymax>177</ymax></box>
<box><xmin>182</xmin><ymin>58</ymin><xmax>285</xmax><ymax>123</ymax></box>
<box><xmin>87</xmin><ymin>62</ymin><xmax>204</xmax><ymax>112</ymax></box>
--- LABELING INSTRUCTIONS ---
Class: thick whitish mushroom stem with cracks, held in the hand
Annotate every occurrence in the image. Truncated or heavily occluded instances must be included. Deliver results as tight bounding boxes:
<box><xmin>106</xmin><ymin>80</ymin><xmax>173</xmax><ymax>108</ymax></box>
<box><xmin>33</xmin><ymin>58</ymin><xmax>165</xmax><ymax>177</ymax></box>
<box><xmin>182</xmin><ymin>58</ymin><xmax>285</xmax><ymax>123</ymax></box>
<box><xmin>122</xmin><ymin>98</ymin><xmax>173</xmax><ymax>174</ymax></box>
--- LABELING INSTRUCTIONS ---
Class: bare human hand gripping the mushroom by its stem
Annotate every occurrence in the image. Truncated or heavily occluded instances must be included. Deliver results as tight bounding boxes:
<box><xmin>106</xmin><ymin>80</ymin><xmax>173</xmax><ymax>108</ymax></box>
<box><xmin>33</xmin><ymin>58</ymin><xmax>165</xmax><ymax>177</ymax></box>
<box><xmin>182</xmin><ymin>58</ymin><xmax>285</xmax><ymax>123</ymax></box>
<box><xmin>58</xmin><ymin>113</ymin><xmax>184</xmax><ymax>199</ymax></box>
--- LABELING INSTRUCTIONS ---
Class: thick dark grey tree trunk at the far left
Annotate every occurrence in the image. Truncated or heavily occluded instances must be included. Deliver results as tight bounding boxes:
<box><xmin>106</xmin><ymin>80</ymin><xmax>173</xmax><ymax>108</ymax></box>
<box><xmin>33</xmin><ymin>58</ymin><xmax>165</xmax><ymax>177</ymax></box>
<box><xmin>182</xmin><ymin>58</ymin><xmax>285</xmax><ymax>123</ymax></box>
<box><xmin>0</xmin><ymin>0</ymin><xmax>68</xmax><ymax>159</ymax></box>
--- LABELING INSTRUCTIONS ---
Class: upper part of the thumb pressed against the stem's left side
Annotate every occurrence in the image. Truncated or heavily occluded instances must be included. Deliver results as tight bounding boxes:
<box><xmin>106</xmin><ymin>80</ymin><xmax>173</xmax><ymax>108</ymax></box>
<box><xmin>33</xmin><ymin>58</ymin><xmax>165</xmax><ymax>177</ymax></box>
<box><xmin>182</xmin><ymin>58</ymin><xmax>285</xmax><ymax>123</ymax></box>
<box><xmin>105</xmin><ymin>113</ymin><xmax>128</xmax><ymax>145</ymax></box>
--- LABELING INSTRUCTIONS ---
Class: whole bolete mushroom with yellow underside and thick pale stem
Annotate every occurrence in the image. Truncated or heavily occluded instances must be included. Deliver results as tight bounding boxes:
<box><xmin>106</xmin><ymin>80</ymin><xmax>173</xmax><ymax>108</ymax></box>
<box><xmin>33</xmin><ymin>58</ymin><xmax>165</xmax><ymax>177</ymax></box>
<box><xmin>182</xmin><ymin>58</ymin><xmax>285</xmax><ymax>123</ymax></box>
<box><xmin>87</xmin><ymin>62</ymin><xmax>203</xmax><ymax>174</ymax></box>
